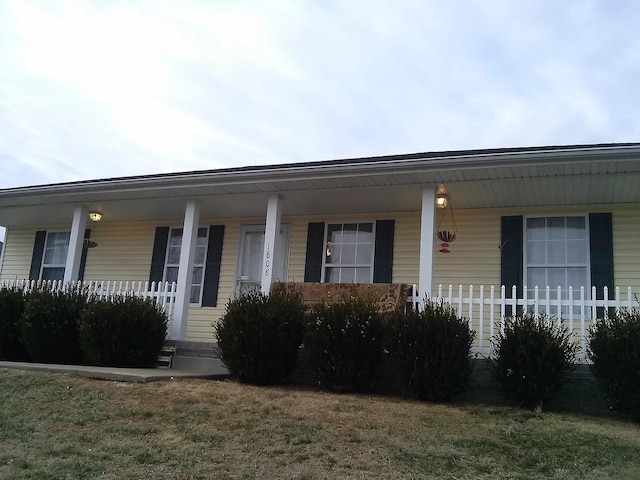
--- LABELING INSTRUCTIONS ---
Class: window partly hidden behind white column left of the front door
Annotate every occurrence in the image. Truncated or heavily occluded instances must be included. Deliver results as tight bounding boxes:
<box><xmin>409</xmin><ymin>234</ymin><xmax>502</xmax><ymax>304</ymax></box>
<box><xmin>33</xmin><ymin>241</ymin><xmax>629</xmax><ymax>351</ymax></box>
<box><xmin>163</xmin><ymin>227</ymin><xmax>209</xmax><ymax>304</ymax></box>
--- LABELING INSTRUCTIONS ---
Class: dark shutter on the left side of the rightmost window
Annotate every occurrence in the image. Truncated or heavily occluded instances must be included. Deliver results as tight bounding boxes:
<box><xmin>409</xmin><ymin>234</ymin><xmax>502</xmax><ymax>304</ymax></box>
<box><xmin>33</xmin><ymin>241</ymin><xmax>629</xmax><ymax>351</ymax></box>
<box><xmin>500</xmin><ymin>215</ymin><xmax>524</xmax><ymax>315</ymax></box>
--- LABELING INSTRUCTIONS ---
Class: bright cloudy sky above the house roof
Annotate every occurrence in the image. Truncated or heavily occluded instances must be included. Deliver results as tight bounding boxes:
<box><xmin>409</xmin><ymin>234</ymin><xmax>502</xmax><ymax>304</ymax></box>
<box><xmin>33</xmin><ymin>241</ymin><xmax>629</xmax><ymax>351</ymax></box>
<box><xmin>0</xmin><ymin>0</ymin><xmax>640</xmax><ymax>193</ymax></box>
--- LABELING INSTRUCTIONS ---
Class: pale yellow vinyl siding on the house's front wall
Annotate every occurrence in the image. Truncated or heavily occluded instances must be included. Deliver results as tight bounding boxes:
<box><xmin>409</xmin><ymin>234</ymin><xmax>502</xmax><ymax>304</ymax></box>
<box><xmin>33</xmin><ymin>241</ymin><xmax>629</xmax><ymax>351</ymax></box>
<box><xmin>0</xmin><ymin>205</ymin><xmax>640</xmax><ymax>345</ymax></box>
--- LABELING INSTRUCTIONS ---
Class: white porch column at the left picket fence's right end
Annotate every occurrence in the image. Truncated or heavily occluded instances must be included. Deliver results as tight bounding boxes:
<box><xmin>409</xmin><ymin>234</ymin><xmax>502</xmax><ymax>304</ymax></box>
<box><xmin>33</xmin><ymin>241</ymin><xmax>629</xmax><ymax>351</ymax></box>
<box><xmin>170</xmin><ymin>200</ymin><xmax>200</xmax><ymax>340</ymax></box>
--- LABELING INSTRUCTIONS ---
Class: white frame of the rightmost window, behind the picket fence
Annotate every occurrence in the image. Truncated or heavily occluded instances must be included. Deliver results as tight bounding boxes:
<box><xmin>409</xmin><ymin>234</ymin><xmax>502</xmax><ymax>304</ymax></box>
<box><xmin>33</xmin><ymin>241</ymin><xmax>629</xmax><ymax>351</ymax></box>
<box><xmin>522</xmin><ymin>213</ymin><xmax>591</xmax><ymax>311</ymax></box>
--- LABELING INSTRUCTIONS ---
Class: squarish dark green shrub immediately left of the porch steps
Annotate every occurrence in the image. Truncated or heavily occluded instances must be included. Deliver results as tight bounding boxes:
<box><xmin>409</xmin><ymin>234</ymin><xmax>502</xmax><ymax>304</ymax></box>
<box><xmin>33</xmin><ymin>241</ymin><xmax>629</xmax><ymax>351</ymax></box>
<box><xmin>79</xmin><ymin>295</ymin><xmax>167</xmax><ymax>368</ymax></box>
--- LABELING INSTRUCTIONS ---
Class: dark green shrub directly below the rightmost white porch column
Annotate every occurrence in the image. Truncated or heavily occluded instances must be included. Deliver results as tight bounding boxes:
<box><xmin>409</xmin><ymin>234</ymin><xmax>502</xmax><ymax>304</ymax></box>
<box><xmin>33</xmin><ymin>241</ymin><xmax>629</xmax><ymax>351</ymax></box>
<box><xmin>387</xmin><ymin>300</ymin><xmax>475</xmax><ymax>402</ymax></box>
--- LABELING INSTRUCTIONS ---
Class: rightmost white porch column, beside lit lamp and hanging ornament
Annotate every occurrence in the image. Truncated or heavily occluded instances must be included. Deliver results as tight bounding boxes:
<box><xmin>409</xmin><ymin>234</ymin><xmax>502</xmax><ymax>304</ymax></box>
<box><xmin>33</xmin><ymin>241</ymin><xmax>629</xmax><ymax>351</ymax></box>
<box><xmin>418</xmin><ymin>185</ymin><xmax>436</xmax><ymax>302</ymax></box>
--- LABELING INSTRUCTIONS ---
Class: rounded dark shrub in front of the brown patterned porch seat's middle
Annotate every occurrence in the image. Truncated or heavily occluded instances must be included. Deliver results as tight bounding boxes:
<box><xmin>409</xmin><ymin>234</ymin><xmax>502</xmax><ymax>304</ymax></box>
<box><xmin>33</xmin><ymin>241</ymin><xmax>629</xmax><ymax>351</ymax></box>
<box><xmin>304</xmin><ymin>297</ymin><xmax>384</xmax><ymax>392</ymax></box>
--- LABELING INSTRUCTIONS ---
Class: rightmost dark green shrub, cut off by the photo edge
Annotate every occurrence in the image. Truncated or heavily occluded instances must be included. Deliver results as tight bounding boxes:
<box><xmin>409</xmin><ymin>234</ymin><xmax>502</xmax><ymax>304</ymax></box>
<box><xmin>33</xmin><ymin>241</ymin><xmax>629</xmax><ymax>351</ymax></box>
<box><xmin>587</xmin><ymin>310</ymin><xmax>640</xmax><ymax>421</ymax></box>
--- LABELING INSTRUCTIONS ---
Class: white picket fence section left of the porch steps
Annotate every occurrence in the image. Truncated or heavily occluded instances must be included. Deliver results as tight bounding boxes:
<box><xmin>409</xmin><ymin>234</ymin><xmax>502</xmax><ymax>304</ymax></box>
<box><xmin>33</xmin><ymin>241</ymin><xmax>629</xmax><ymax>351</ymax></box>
<box><xmin>0</xmin><ymin>280</ymin><xmax>176</xmax><ymax>327</ymax></box>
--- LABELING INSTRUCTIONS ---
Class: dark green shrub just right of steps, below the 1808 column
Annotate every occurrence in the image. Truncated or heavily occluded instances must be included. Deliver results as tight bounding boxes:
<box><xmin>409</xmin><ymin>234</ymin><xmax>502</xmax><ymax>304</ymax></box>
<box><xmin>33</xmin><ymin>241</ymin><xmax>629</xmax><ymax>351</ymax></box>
<box><xmin>215</xmin><ymin>285</ymin><xmax>305</xmax><ymax>385</ymax></box>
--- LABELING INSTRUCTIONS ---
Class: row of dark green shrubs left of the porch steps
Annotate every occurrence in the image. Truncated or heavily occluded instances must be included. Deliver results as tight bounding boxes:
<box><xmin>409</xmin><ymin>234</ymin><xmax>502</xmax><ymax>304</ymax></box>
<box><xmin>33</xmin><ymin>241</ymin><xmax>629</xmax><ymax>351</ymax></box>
<box><xmin>0</xmin><ymin>287</ymin><xmax>167</xmax><ymax>367</ymax></box>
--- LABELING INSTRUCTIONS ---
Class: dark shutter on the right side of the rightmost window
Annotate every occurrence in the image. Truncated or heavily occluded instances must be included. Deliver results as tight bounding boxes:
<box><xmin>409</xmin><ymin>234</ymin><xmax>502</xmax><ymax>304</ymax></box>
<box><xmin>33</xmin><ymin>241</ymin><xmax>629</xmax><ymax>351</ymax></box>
<box><xmin>589</xmin><ymin>213</ymin><xmax>614</xmax><ymax>318</ymax></box>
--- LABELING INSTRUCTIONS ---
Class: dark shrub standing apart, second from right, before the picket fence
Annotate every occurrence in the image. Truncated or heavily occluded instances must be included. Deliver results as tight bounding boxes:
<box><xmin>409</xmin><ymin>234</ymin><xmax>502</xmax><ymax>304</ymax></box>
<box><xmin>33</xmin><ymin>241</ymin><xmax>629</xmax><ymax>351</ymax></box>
<box><xmin>489</xmin><ymin>313</ymin><xmax>579</xmax><ymax>412</ymax></box>
